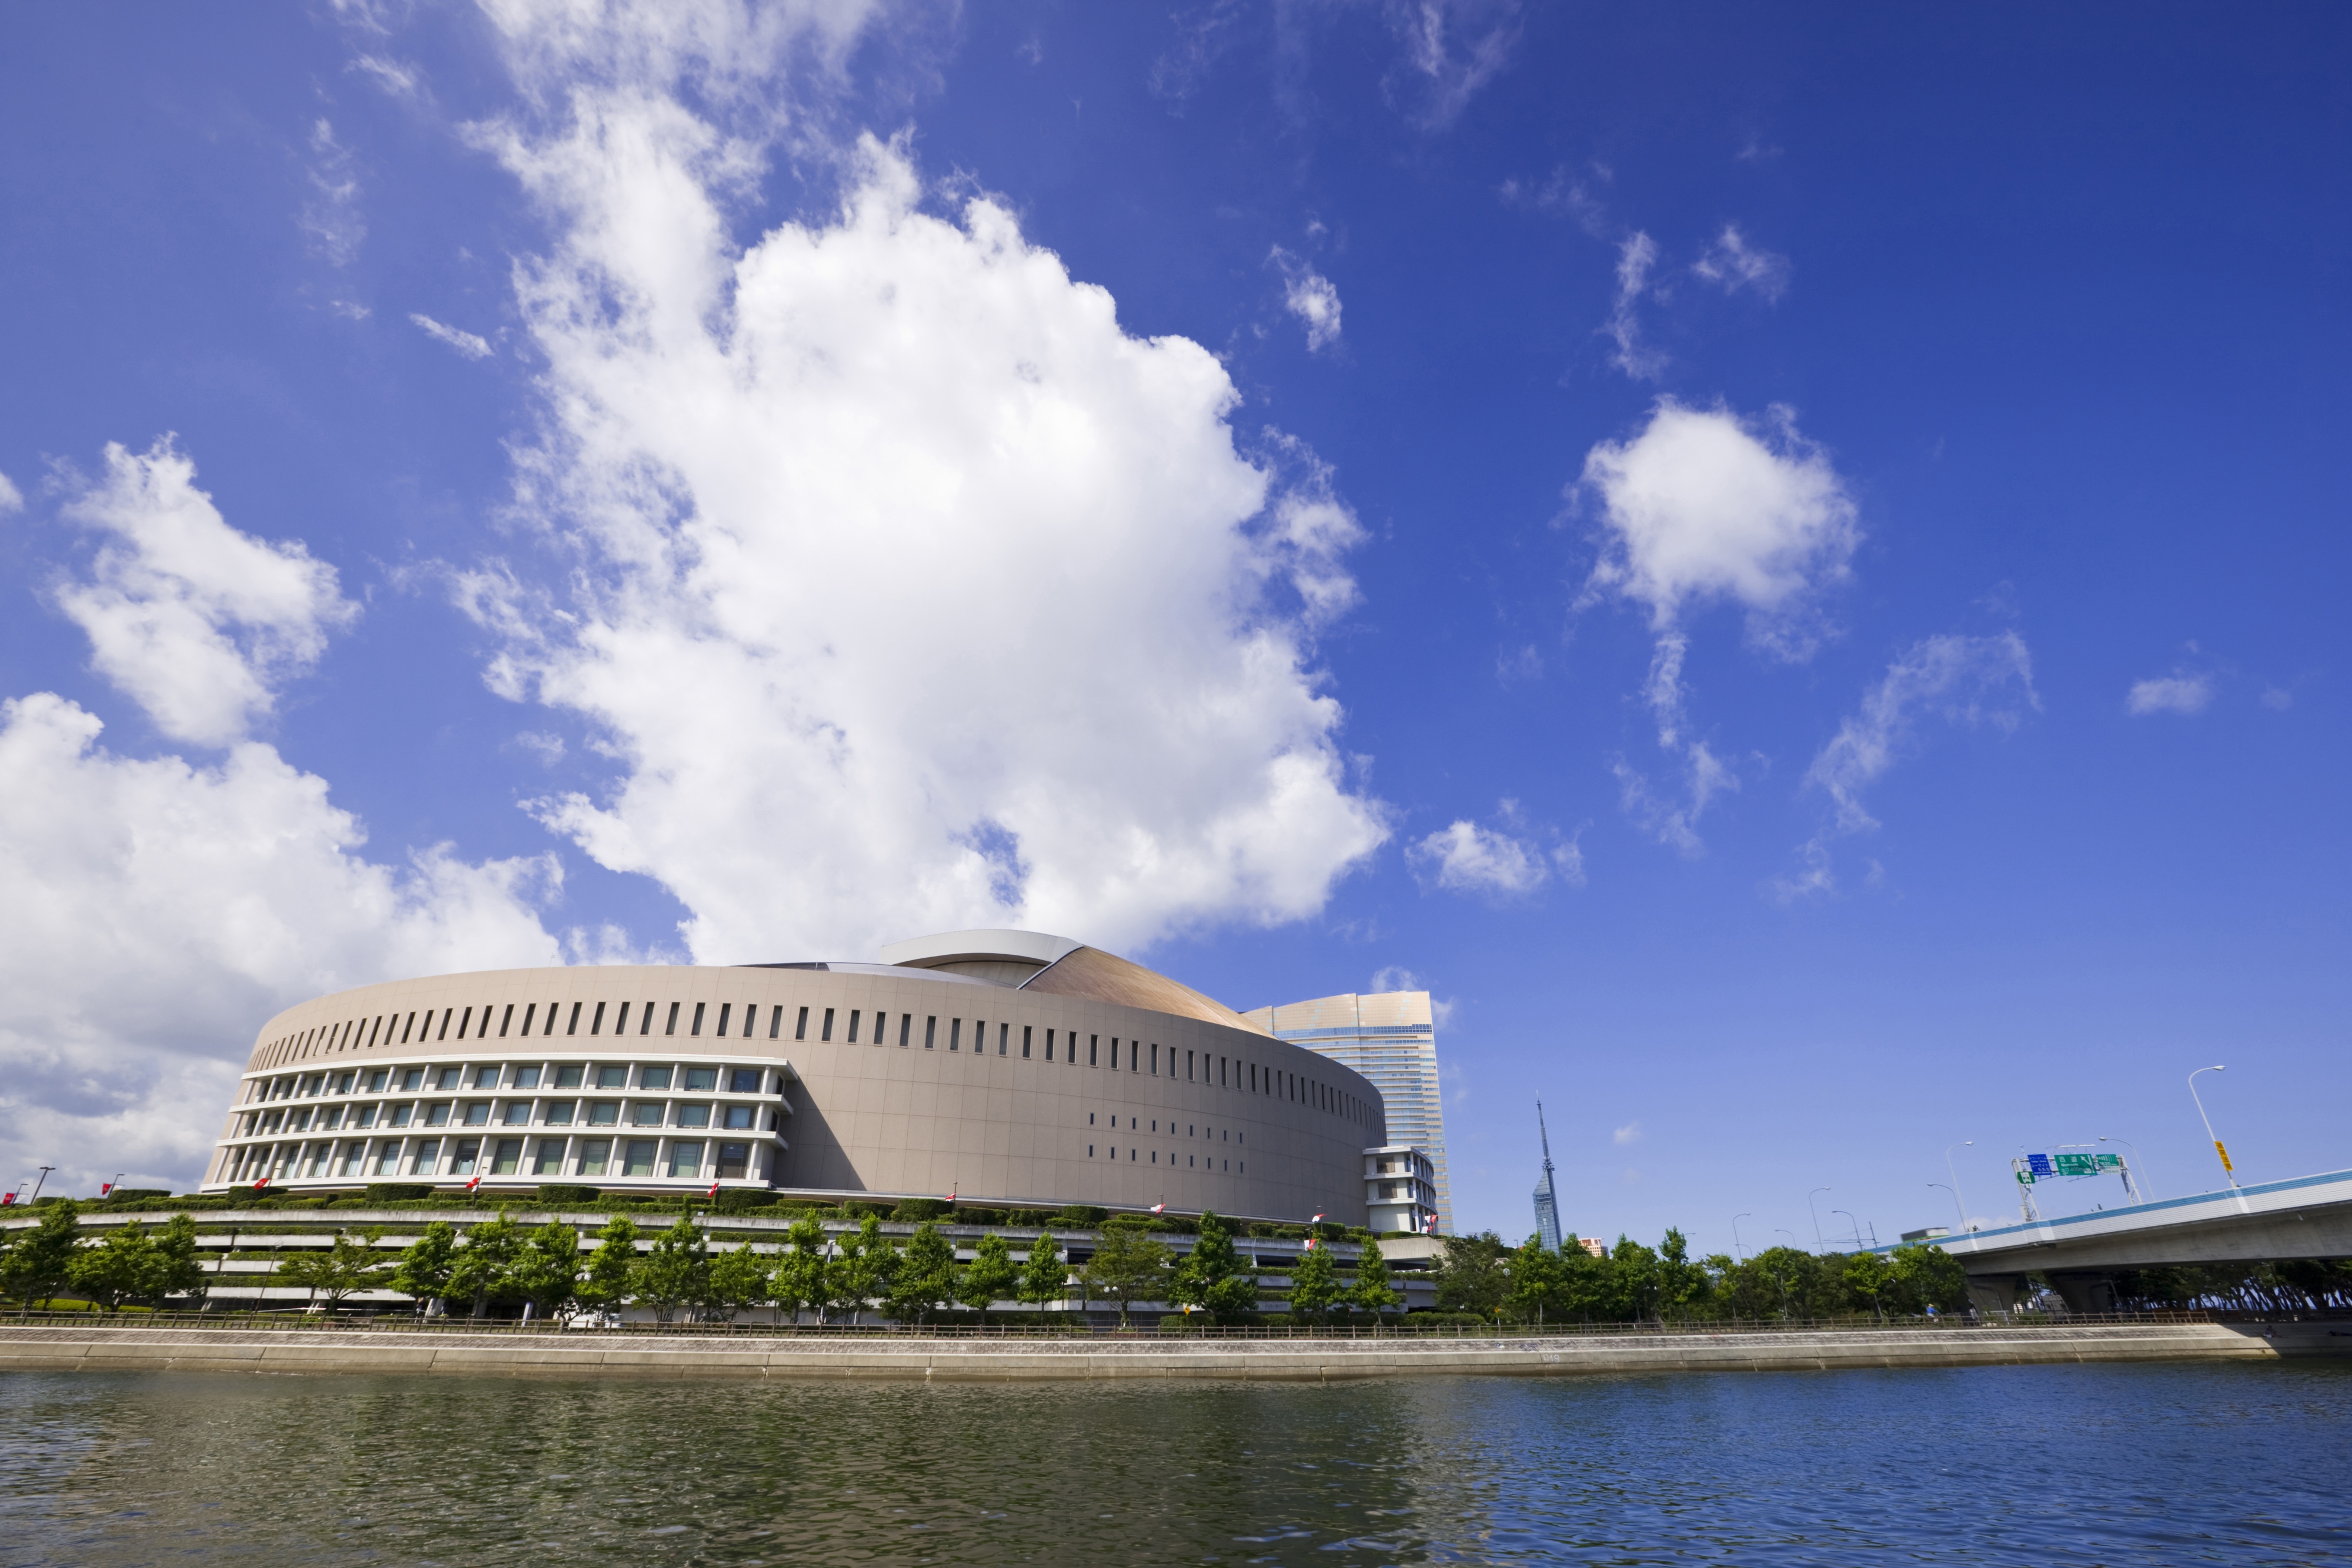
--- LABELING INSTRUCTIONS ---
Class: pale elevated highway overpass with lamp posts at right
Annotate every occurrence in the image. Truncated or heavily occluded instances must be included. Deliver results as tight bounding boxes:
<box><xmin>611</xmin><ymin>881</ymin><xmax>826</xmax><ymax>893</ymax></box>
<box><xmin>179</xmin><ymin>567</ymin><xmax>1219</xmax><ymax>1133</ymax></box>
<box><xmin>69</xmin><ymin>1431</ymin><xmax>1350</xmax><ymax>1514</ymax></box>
<box><xmin>1879</xmin><ymin>1171</ymin><xmax>2352</xmax><ymax>1312</ymax></box>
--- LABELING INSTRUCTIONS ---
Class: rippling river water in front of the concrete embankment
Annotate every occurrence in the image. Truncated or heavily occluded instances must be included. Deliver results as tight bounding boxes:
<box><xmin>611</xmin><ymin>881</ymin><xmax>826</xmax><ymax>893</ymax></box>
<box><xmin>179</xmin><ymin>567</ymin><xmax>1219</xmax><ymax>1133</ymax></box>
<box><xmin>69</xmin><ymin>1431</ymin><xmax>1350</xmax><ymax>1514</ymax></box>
<box><xmin>0</xmin><ymin>1363</ymin><xmax>2352</xmax><ymax>1568</ymax></box>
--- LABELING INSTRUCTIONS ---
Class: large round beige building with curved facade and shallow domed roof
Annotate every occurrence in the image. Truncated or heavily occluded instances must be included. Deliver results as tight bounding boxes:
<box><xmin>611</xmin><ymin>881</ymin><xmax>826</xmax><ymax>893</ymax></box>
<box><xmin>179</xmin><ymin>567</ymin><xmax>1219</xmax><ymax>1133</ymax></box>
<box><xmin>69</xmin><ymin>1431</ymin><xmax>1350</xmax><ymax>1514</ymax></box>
<box><xmin>207</xmin><ymin>933</ymin><xmax>1385</xmax><ymax>1225</ymax></box>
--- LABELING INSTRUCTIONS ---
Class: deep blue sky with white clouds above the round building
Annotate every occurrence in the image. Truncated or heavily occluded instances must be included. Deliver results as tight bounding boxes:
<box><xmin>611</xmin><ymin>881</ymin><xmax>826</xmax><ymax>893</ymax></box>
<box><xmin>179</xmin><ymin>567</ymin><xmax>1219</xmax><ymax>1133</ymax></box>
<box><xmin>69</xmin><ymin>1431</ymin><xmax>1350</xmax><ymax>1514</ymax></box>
<box><xmin>0</xmin><ymin>0</ymin><xmax>2352</xmax><ymax>1251</ymax></box>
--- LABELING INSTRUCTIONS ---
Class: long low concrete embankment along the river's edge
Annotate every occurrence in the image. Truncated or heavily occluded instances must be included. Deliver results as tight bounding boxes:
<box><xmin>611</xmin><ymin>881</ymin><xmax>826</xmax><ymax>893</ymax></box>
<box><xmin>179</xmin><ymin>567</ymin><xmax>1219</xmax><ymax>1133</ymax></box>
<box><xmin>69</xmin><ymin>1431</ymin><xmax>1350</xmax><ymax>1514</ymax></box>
<box><xmin>0</xmin><ymin>1323</ymin><xmax>2352</xmax><ymax>1382</ymax></box>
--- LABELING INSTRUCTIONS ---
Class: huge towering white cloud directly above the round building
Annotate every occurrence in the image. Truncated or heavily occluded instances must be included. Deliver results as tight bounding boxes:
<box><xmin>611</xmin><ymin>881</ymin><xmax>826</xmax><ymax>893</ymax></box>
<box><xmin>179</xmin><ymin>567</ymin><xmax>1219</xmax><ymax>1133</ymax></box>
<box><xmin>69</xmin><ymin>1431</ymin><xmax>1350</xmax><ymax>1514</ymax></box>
<box><xmin>466</xmin><ymin>34</ymin><xmax>1388</xmax><ymax>961</ymax></box>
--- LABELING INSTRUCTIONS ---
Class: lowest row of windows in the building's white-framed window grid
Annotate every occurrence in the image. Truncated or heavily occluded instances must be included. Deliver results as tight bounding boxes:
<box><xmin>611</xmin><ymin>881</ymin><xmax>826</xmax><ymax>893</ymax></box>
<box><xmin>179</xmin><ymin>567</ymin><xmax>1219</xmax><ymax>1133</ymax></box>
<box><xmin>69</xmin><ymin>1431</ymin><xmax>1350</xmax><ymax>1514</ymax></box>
<box><xmin>219</xmin><ymin>1138</ymin><xmax>753</xmax><ymax>1182</ymax></box>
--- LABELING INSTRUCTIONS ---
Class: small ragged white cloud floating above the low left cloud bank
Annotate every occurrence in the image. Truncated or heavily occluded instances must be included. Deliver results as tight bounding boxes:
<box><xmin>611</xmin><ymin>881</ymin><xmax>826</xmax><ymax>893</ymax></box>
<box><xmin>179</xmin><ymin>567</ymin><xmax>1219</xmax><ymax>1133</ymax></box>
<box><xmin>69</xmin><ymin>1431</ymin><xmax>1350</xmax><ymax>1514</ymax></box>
<box><xmin>54</xmin><ymin>437</ymin><xmax>358</xmax><ymax>745</ymax></box>
